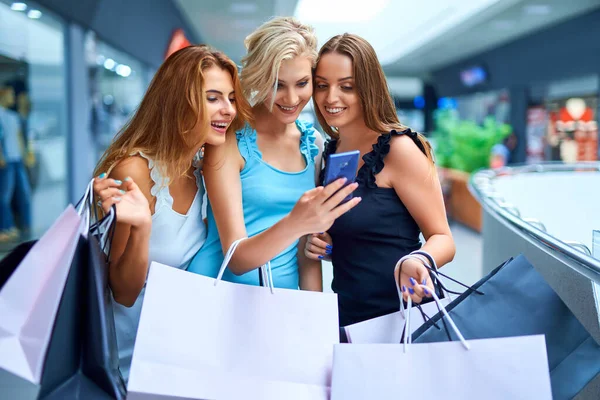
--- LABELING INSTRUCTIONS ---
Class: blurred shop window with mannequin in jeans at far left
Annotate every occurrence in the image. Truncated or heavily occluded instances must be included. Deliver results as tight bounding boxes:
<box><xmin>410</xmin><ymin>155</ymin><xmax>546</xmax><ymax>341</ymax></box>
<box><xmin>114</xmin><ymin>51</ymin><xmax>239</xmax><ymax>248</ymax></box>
<box><xmin>0</xmin><ymin>0</ymin><xmax>67</xmax><ymax>250</ymax></box>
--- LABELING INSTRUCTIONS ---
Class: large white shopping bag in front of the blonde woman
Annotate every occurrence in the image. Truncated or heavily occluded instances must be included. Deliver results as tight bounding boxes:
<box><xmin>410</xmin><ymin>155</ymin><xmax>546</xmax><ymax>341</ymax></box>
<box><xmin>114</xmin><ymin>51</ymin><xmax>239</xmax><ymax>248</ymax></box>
<box><xmin>128</xmin><ymin>239</ymin><xmax>339</xmax><ymax>400</ymax></box>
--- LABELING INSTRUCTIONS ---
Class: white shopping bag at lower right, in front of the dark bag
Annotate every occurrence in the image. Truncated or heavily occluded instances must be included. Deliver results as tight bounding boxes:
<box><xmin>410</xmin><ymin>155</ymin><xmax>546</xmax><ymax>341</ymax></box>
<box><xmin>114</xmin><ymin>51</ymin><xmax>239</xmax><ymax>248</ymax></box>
<box><xmin>331</xmin><ymin>284</ymin><xmax>552</xmax><ymax>400</ymax></box>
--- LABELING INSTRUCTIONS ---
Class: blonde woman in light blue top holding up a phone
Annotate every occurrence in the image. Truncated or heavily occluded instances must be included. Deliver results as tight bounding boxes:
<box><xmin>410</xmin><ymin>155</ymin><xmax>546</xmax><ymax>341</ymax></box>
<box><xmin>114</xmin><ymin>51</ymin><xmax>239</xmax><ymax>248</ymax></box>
<box><xmin>188</xmin><ymin>17</ymin><xmax>360</xmax><ymax>291</ymax></box>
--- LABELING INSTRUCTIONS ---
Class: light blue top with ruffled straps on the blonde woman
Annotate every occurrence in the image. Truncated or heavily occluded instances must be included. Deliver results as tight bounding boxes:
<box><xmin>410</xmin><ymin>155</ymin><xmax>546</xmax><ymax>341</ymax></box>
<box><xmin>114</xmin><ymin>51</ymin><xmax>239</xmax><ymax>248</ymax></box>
<box><xmin>188</xmin><ymin>120</ymin><xmax>319</xmax><ymax>289</ymax></box>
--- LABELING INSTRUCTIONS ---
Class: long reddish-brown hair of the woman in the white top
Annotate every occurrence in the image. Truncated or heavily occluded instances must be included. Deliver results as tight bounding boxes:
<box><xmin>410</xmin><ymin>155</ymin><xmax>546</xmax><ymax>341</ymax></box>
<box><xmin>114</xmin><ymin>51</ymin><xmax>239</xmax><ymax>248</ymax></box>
<box><xmin>94</xmin><ymin>45</ymin><xmax>250</xmax><ymax>182</ymax></box>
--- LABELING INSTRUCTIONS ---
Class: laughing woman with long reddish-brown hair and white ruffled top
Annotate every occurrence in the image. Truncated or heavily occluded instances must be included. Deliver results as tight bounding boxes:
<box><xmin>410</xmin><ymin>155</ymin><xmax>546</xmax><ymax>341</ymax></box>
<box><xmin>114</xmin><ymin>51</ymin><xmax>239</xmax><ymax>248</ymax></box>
<box><xmin>94</xmin><ymin>46</ymin><xmax>250</xmax><ymax>379</ymax></box>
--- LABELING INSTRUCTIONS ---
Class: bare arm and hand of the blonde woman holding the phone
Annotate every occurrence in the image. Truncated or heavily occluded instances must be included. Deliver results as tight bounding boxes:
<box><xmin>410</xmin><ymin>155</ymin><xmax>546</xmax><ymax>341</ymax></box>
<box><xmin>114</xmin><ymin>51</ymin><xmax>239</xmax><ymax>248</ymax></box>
<box><xmin>203</xmin><ymin>137</ymin><xmax>360</xmax><ymax>275</ymax></box>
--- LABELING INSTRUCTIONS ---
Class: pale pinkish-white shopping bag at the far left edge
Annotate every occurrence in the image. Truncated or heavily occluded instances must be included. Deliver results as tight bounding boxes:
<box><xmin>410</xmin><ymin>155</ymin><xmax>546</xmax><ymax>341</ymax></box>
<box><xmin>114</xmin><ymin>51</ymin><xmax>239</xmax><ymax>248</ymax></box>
<box><xmin>0</xmin><ymin>206</ymin><xmax>81</xmax><ymax>390</ymax></box>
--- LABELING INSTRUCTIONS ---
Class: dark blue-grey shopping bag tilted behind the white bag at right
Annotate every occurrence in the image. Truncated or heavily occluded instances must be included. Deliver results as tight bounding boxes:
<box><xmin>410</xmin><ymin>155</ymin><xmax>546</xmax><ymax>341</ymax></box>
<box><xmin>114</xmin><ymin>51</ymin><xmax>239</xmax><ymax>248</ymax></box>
<box><xmin>412</xmin><ymin>255</ymin><xmax>600</xmax><ymax>400</ymax></box>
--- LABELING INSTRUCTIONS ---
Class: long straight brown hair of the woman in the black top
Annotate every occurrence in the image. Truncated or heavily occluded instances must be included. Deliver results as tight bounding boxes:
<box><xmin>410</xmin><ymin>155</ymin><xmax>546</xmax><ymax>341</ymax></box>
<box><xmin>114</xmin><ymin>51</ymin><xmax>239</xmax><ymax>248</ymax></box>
<box><xmin>313</xmin><ymin>33</ymin><xmax>433</xmax><ymax>161</ymax></box>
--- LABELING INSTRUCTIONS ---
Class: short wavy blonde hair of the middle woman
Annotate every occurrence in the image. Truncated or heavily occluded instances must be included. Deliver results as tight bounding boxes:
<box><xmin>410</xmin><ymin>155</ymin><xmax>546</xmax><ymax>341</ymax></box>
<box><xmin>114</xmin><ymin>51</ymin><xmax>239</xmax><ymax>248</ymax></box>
<box><xmin>240</xmin><ymin>17</ymin><xmax>317</xmax><ymax>110</ymax></box>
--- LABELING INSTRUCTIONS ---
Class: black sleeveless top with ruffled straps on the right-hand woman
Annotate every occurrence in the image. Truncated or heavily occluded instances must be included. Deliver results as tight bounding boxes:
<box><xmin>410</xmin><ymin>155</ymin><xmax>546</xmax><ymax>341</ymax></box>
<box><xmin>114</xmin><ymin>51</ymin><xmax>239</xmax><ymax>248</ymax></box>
<box><xmin>321</xmin><ymin>129</ymin><xmax>425</xmax><ymax>326</ymax></box>
